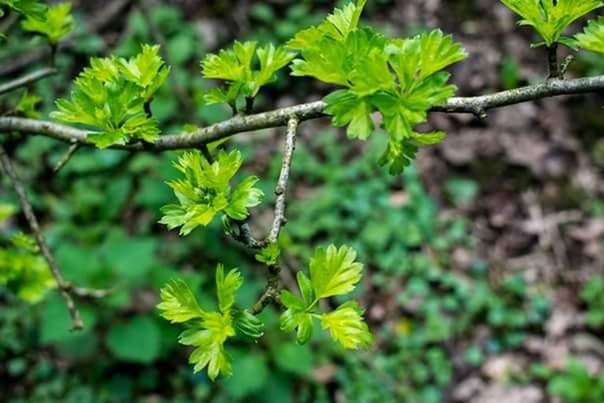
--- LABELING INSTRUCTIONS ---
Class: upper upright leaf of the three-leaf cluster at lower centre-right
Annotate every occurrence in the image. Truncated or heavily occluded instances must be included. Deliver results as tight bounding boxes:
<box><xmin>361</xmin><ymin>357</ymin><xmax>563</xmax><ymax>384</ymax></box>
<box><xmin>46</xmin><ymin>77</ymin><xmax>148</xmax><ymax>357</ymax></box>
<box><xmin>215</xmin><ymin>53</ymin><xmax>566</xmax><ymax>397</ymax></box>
<box><xmin>310</xmin><ymin>245</ymin><xmax>363</xmax><ymax>298</ymax></box>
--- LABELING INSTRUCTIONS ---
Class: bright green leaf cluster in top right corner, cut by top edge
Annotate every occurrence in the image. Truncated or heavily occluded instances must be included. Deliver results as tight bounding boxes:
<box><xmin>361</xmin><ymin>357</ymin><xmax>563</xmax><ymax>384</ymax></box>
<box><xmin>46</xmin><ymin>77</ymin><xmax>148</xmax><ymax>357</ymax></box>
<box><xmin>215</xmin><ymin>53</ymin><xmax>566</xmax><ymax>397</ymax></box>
<box><xmin>501</xmin><ymin>0</ymin><xmax>604</xmax><ymax>47</ymax></box>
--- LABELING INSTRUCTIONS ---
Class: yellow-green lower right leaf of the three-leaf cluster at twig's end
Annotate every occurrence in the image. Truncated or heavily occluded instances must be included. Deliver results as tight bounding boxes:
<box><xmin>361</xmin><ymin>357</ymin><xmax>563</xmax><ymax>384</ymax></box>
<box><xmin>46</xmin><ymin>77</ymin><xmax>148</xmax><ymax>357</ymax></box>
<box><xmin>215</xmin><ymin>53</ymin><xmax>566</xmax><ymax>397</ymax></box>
<box><xmin>320</xmin><ymin>301</ymin><xmax>373</xmax><ymax>350</ymax></box>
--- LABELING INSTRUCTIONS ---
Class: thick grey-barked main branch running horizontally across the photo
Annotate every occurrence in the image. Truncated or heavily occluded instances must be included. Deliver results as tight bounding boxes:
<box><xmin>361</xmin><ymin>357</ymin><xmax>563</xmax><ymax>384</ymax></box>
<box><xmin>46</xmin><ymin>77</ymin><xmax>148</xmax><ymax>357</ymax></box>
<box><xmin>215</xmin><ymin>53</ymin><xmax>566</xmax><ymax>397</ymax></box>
<box><xmin>0</xmin><ymin>75</ymin><xmax>604</xmax><ymax>151</ymax></box>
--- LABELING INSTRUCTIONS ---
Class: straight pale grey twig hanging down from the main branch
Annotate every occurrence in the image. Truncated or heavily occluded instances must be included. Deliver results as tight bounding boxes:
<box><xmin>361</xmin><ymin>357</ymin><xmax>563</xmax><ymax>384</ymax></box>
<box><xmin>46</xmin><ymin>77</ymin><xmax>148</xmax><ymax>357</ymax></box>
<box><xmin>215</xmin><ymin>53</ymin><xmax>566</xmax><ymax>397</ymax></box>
<box><xmin>266</xmin><ymin>116</ymin><xmax>298</xmax><ymax>244</ymax></box>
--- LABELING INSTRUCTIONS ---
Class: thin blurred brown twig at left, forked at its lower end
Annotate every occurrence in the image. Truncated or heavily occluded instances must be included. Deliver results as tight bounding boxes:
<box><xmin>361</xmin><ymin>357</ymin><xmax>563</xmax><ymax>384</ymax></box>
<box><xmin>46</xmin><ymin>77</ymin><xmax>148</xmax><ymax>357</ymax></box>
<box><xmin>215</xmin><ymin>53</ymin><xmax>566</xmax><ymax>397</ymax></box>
<box><xmin>0</xmin><ymin>145</ymin><xmax>111</xmax><ymax>330</ymax></box>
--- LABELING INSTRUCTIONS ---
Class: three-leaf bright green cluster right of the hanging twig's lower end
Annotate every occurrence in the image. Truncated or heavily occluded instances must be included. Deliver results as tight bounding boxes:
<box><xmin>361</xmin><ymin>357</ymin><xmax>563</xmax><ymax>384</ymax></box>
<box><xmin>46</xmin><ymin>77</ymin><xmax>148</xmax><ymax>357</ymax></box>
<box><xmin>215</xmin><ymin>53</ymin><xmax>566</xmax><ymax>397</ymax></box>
<box><xmin>280</xmin><ymin>245</ymin><xmax>373</xmax><ymax>349</ymax></box>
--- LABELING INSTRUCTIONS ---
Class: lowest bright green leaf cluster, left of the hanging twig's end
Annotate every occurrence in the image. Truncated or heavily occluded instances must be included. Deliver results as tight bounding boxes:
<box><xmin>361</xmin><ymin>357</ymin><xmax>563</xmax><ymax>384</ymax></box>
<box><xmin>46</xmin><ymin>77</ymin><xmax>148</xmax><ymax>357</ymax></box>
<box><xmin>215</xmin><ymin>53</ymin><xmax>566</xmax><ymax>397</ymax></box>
<box><xmin>157</xmin><ymin>264</ymin><xmax>263</xmax><ymax>380</ymax></box>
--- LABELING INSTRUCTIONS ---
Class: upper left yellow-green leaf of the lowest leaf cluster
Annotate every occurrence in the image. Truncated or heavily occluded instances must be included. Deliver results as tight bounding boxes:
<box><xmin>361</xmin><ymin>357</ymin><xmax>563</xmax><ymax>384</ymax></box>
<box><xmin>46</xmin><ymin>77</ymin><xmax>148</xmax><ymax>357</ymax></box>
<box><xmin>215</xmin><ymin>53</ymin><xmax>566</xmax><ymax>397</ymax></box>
<box><xmin>157</xmin><ymin>279</ymin><xmax>205</xmax><ymax>323</ymax></box>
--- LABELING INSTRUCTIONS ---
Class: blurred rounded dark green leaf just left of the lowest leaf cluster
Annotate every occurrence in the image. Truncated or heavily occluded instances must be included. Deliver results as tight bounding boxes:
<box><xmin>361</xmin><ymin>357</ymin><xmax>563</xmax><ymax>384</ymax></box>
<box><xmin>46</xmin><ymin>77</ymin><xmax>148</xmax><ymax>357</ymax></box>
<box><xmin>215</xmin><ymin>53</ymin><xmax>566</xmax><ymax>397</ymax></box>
<box><xmin>107</xmin><ymin>316</ymin><xmax>161</xmax><ymax>364</ymax></box>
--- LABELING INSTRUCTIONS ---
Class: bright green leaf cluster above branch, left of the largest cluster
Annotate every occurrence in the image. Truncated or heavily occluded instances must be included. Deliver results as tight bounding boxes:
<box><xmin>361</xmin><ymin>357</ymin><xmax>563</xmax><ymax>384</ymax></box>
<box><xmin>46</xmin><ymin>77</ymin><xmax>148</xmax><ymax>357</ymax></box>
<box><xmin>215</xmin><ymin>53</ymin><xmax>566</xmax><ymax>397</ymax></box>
<box><xmin>201</xmin><ymin>41</ymin><xmax>294</xmax><ymax>110</ymax></box>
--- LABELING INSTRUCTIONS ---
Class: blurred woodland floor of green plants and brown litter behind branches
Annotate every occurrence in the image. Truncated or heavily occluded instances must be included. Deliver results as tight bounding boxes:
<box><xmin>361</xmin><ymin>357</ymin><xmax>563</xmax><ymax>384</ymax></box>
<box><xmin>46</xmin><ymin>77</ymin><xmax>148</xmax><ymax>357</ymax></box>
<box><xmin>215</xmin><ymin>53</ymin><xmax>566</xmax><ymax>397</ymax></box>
<box><xmin>0</xmin><ymin>0</ymin><xmax>604</xmax><ymax>403</ymax></box>
